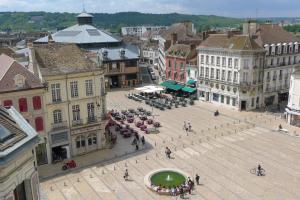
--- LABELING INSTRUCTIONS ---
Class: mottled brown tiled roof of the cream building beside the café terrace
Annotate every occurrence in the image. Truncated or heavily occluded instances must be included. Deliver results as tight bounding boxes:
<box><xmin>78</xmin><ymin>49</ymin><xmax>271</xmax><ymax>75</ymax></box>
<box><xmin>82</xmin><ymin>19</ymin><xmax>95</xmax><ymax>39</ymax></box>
<box><xmin>34</xmin><ymin>43</ymin><xmax>99</xmax><ymax>75</ymax></box>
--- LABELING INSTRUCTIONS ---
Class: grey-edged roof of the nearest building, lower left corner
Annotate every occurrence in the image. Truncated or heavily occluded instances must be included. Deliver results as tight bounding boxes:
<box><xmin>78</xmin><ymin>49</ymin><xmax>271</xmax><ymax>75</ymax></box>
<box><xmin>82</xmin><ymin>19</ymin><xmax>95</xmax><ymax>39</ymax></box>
<box><xmin>0</xmin><ymin>106</ymin><xmax>39</xmax><ymax>165</ymax></box>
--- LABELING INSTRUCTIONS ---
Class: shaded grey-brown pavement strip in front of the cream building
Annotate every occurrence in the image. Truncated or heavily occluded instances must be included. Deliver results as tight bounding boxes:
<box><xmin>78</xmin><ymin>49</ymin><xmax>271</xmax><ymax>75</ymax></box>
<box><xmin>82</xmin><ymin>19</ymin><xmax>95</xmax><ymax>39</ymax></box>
<box><xmin>38</xmin><ymin>135</ymin><xmax>152</xmax><ymax>181</ymax></box>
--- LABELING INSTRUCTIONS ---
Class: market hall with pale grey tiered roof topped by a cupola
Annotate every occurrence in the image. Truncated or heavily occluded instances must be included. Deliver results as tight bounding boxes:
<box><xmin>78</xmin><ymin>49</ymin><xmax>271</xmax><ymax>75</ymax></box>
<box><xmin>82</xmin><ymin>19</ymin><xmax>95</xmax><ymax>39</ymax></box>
<box><xmin>34</xmin><ymin>11</ymin><xmax>140</xmax><ymax>88</ymax></box>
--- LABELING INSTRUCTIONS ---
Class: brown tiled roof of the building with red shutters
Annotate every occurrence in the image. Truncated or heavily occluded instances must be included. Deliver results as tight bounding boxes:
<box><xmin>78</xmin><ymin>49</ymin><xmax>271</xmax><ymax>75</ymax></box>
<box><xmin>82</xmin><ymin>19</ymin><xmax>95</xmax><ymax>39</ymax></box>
<box><xmin>0</xmin><ymin>54</ymin><xmax>43</xmax><ymax>92</ymax></box>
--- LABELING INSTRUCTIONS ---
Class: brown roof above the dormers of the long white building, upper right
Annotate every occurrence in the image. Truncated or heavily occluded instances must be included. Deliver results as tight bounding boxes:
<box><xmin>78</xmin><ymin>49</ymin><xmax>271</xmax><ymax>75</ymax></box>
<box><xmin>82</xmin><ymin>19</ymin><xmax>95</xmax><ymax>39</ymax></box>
<box><xmin>256</xmin><ymin>24</ymin><xmax>299</xmax><ymax>46</ymax></box>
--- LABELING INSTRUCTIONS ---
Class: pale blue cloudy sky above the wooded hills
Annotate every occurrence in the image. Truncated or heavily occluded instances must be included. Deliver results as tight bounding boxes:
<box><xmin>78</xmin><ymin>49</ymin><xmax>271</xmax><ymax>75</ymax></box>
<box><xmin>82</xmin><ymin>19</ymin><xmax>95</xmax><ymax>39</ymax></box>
<box><xmin>0</xmin><ymin>0</ymin><xmax>300</xmax><ymax>18</ymax></box>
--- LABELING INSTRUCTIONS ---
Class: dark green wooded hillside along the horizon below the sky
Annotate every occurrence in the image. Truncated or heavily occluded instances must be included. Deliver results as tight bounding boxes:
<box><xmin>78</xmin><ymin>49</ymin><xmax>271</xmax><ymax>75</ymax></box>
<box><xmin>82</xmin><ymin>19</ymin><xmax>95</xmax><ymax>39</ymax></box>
<box><xmin>0</xmin><ymin>12</ymin><xmax>242</xmax><ymax>32</ymax></box>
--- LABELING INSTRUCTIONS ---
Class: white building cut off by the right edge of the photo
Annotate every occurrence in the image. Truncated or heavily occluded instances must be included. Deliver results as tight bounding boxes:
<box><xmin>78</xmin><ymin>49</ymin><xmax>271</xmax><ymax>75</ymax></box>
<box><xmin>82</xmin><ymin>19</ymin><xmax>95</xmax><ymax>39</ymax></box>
<box><xmin>286</xmin><ymin>67</ymin><xmax>300</xmax><ymax>127</ymax></box>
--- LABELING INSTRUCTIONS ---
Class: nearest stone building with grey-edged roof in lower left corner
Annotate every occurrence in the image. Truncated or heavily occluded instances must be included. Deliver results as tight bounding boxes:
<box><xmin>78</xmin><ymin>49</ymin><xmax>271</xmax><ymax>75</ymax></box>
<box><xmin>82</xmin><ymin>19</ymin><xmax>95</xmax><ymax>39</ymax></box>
<box><xmin>0</xmin><ymin>106</ymin><xmax>40</xmax><ymax>200</ymax></box>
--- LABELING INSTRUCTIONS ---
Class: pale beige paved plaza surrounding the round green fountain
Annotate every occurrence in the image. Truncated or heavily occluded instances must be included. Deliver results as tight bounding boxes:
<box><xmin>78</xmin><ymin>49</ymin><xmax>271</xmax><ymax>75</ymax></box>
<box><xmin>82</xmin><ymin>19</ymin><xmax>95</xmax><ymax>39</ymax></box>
<box><xmin>39</xmin><ymin>91</ymin><xmax>300</xmax><ymax>200</ymax></box>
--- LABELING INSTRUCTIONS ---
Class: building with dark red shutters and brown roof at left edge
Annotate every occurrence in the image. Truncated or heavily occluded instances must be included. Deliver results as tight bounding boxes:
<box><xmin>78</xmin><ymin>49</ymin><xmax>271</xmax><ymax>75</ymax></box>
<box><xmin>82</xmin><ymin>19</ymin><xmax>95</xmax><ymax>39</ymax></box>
<box><xmin>0</xmin><ymin>54</ymin><xmax>50</xmax><ymax>165</ymax></box>
